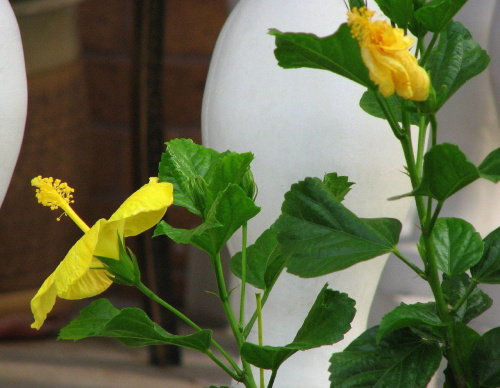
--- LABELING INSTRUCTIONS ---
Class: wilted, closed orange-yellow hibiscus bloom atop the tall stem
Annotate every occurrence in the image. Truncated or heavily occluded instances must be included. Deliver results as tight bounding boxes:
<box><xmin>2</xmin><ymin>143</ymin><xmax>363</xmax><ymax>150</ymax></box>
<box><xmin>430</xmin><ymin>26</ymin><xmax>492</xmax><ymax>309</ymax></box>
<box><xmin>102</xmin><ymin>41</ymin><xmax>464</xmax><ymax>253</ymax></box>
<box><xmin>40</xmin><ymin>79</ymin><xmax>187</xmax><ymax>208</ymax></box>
<box><xmin>347</xmin><ymin>7</ymin><xmax>430</xmax><ymax>101</ymax></box>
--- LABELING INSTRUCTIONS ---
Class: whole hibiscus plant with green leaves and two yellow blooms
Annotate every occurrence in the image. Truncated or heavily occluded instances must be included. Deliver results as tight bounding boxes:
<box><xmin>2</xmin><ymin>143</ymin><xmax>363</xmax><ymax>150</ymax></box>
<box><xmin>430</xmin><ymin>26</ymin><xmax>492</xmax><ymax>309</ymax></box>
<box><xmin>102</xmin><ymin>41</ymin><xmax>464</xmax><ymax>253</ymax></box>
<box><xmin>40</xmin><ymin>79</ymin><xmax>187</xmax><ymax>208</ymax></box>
<box><xmin>32</xmin><ymin>0</ymin><xmax>500</xmax><ymax>388</ymax></box>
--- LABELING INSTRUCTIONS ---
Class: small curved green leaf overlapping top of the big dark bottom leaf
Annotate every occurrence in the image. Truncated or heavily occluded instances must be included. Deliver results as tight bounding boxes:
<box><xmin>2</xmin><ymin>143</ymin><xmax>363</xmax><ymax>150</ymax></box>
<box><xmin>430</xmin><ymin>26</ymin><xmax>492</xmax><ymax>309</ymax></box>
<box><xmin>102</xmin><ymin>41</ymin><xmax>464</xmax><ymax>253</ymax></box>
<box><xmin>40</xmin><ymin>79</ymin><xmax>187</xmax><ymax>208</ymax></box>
<box><xmin>377</xmin><ymin>303</ymin><xmax>443</xmax><ymax>343</ymax></box>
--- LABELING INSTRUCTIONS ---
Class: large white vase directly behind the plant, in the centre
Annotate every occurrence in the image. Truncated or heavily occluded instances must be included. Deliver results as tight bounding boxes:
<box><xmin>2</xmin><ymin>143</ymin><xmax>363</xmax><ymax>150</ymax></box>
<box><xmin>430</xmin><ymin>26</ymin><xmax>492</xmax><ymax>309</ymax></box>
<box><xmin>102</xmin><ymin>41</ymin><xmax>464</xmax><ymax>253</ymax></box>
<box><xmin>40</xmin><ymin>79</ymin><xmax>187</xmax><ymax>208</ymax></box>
<box><xmin>202</xmin><ymin>0</ymin><xmax>410</xmax><ymax>388</ymax></box>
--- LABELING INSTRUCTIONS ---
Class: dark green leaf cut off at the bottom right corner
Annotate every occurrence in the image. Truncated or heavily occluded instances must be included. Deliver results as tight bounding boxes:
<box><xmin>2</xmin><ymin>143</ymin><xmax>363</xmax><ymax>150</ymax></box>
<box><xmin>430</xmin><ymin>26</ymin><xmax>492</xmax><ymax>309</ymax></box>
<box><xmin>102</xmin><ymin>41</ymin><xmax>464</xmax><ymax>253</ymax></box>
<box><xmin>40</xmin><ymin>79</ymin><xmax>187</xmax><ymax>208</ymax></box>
<box><xmin>470</xmin><ymin>327</ymin><xmax>500</xmax><ymax>387</ymax></box>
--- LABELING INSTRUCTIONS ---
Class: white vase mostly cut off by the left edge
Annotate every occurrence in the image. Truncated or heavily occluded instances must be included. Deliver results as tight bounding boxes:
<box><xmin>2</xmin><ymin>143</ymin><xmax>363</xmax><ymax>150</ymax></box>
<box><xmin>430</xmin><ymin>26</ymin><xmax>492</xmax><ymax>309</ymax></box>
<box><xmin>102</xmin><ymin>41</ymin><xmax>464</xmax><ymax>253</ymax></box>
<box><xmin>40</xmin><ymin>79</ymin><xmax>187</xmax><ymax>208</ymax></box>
<box><xmin>0</xmin><ymin>0</ymin><xmax>28</xmax><ymax>206</ymax></box>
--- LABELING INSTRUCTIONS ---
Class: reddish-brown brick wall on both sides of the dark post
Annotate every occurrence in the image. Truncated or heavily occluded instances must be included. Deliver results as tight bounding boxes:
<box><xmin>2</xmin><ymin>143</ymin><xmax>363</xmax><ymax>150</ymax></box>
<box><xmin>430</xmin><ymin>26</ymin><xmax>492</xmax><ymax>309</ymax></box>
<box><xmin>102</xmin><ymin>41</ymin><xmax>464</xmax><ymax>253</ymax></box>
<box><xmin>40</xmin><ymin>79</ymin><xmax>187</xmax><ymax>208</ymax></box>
<box><xmin>79</xmin><ymin>0</ymin><xmax>227</xmax><ymax>301</ymax></box>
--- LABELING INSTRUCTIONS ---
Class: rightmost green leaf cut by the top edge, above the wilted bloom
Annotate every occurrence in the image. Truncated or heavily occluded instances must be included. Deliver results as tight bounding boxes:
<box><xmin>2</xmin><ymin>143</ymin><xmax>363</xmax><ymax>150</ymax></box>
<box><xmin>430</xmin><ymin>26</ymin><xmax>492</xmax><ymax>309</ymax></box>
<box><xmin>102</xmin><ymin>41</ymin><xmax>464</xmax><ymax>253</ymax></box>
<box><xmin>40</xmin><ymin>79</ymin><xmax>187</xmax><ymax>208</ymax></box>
<box><xmin>415</xmin><ymin>0</ymin><xmax>467</xmax><ymax>32</ymax></box>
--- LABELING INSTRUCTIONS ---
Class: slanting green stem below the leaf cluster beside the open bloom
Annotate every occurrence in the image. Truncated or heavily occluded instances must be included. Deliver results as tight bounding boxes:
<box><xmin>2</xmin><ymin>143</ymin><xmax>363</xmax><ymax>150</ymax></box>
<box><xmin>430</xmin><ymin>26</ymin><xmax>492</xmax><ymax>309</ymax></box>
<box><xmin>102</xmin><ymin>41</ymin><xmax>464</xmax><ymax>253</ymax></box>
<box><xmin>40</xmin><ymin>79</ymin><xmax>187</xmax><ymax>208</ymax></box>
<box><xmin>210</xmin><ymin>253</ymin><xmax>257</xmax><ymax>388</ymax></box>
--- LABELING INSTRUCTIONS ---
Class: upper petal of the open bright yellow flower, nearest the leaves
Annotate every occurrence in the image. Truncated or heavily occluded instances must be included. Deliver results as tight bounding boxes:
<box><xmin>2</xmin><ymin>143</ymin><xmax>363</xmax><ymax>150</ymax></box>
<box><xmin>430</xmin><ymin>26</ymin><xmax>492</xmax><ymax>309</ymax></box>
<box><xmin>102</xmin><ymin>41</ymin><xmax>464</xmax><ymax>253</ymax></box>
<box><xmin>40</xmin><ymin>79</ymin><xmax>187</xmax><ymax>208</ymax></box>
<box><xmin>109</xmin><ymin>179</ymin><xmax>174</xmax><ymax>237</ymax></box>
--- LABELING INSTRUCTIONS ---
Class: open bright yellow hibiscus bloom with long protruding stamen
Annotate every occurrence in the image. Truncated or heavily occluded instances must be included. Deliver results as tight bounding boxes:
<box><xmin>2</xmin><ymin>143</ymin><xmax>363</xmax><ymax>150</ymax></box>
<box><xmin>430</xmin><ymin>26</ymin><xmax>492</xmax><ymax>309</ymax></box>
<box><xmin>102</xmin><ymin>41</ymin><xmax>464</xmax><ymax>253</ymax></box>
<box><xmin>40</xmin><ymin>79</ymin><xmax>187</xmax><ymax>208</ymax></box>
<box><xmin>31</xmin><ymin>176</ymin><xmax>173</xmax><ymax>329</ymax></box>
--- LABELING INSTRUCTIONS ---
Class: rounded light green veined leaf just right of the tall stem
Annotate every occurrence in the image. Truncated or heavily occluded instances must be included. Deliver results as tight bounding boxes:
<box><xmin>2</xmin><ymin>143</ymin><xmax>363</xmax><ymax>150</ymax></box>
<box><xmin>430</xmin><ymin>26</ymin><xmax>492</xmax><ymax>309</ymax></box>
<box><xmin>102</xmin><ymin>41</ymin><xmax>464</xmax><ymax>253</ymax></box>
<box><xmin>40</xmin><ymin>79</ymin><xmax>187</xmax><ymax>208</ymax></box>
<box><xmin>432</xmin><ymin>218</ymin><xmax>484</xmax><ymax>275</ymax></box>
